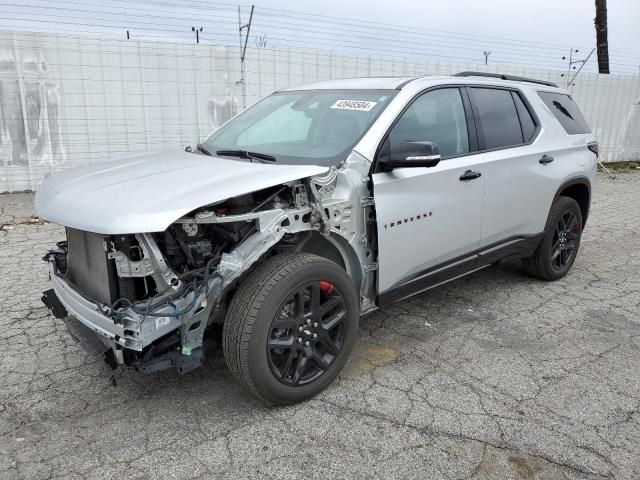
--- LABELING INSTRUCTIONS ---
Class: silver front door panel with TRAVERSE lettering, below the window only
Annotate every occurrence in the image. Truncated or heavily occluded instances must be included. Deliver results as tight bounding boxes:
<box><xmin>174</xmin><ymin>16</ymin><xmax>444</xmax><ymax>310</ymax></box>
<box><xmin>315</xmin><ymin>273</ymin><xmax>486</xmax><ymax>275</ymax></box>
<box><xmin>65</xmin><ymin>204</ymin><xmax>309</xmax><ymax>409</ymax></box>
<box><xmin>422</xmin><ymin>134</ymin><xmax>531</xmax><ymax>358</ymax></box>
<box><xmin>373</xmin><ymin>155</ymin><xmax>485</xmax><ymax>293</ymax></box>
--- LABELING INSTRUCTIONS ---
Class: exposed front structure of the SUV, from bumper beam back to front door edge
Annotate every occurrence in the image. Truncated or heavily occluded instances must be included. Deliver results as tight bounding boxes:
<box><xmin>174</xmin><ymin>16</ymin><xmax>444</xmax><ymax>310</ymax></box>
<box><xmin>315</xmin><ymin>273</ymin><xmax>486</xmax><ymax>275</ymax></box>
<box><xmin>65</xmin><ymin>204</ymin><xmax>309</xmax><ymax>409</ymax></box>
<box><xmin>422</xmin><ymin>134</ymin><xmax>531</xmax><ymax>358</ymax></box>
<box><xmin>43</xmin><ymin>154</ymin><xmax>376</xmax><ymax>373</ymax></box>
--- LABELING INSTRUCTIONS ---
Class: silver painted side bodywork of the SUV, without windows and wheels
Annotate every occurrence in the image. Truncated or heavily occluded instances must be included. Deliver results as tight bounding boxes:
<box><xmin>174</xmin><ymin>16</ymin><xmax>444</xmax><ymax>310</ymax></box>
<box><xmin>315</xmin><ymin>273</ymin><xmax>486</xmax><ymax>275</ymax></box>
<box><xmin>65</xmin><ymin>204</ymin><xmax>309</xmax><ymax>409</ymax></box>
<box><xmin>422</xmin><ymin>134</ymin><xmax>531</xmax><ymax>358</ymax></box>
<box><xmin>368</xmin><ymin>77</ymin><xmax>597</xmax><ymax>294</ymax></box>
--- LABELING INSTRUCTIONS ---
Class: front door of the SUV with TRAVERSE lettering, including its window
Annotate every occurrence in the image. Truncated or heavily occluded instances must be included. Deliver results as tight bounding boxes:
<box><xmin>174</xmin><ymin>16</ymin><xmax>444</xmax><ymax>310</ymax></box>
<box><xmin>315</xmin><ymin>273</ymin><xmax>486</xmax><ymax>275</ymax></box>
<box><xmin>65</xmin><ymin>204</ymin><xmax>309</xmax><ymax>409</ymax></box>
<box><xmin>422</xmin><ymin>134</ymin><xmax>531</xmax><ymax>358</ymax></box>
<box><xmin>373</xmin><ymin>88</ymin><xmax>485</xmax><ymax>294</ymax></box>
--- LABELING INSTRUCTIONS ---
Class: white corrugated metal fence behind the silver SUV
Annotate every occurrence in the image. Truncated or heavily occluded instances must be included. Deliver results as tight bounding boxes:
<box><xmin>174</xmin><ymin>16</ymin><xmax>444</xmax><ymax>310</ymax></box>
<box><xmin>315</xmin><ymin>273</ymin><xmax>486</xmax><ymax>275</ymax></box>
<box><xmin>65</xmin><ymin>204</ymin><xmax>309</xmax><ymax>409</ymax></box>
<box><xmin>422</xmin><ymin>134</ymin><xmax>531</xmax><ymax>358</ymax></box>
<box><xmin>0</xmin><ymin>32</ymin><xmax>640</xmax><ymax>192</ymax></box>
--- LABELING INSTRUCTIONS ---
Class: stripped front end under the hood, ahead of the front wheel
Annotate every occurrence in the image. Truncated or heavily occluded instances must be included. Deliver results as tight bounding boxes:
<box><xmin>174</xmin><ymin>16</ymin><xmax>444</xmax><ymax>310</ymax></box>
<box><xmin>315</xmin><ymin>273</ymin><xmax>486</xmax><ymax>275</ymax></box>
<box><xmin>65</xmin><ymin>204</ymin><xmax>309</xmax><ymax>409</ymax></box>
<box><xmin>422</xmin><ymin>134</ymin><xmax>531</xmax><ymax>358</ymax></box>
<box><xmin>43</xmin><ymin>182</ymin><xmax>320</xmax><ymax>373</ymax></box>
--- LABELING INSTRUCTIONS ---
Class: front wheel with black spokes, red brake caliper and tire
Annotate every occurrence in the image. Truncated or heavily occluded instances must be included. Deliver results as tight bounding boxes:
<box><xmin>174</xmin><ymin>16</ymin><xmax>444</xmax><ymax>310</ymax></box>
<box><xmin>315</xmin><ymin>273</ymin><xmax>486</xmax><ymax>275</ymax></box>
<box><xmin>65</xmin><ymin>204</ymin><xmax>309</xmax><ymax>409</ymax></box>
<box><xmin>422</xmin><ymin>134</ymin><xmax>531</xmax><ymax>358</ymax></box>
<box><xmin>222</xmin><ymin>254</ymin><xmax>360</xmax><ymax>404</ymax></box>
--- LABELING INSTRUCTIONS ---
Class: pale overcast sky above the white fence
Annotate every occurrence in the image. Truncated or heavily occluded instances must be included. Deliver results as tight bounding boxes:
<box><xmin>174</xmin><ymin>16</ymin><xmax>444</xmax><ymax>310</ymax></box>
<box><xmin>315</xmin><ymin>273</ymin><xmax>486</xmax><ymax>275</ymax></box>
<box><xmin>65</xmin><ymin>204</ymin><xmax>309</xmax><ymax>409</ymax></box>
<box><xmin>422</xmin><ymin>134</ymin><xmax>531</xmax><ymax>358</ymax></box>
<box><xmin>6</xmin><ymin>0</ymin><xmax>640</xmax><ymax>75</ymax></box>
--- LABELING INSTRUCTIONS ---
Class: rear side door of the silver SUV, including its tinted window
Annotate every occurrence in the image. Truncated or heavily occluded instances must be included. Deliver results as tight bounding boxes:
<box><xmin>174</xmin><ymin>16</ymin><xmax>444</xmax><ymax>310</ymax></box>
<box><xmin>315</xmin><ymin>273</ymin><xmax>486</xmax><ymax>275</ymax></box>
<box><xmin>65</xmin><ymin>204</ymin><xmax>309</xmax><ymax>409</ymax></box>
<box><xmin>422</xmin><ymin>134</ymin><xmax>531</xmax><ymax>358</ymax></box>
<box><xmin>468</xmin><ymin>87</ymin><xmax>557</xmax><ymax>247</ymax></box>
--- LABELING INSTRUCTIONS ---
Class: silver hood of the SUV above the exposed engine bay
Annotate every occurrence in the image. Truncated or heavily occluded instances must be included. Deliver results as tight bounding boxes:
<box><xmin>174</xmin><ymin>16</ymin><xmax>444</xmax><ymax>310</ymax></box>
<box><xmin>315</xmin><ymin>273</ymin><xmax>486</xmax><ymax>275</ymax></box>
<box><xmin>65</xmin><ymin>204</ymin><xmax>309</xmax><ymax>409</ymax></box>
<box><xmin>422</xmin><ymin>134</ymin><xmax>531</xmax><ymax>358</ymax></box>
<box><xmin>35</xmin><ymin>149</ymin><xmax>328</xmax><ymax>234</ymax></box>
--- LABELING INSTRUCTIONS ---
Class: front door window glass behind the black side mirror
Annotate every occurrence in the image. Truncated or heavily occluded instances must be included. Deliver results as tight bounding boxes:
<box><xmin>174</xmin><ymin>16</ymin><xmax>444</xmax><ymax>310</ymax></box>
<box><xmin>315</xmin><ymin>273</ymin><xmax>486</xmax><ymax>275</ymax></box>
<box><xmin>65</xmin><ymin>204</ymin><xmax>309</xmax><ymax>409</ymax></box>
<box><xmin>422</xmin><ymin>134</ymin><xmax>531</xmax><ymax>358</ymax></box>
<box><xmin>389</xmin><ymin>88</ymin><xmax>469</xmax><ymax>158</ymax></box>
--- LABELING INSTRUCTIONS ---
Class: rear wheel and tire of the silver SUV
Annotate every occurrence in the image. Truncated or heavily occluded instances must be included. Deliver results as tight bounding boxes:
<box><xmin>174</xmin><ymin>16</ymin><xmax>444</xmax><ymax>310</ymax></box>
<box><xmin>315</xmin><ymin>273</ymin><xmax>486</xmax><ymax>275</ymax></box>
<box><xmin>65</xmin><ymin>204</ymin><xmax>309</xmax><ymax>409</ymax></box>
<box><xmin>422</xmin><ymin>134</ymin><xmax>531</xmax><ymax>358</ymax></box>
<box><xmin>522</xmin><ymin>197</ymin><xmax>582</xmax><ymax>281</ymax></box>
